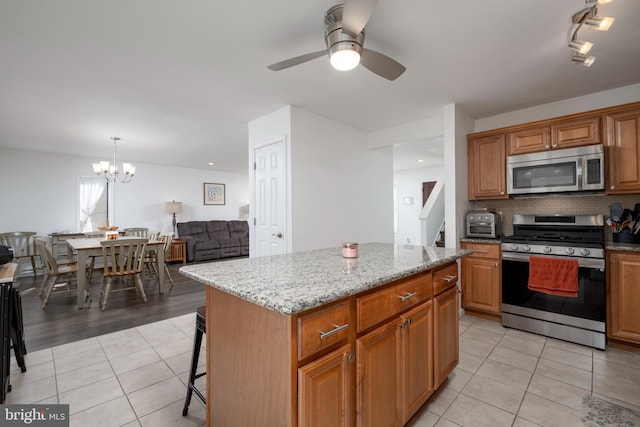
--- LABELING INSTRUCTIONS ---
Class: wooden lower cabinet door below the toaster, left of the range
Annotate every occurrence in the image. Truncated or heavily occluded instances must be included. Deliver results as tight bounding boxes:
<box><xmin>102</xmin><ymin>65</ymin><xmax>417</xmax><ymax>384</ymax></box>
<box><xmin>462</xmin><ymin>255</ymin><xmax>502</xmax><ymax>314</ymax></box>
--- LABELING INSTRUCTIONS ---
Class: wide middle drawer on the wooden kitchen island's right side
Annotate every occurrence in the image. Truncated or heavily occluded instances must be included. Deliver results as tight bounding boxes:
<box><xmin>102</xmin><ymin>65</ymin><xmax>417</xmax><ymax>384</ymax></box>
<box><xmin>356</xmin><ymin>273</ymin><xmax>433</xmax><ymax>332</ymax></box>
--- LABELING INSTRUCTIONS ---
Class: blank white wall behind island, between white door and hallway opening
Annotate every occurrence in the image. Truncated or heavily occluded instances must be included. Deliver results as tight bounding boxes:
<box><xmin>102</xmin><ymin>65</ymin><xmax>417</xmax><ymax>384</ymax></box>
<box><xmin>291</xmin><ymin>107</ymin><xmax>393</xmax><ymax>251</ymax></box>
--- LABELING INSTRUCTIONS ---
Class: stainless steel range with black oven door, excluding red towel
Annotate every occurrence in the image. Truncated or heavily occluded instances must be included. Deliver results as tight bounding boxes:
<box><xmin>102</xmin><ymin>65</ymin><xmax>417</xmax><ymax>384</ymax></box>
<box><xmin>502</xmin><ymin>215</ymin><xmax>606</xmax><ymax>350</ymax></box>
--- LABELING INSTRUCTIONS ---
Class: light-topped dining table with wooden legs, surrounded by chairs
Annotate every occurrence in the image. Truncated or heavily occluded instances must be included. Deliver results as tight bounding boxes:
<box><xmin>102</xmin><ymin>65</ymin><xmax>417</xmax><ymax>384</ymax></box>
<box><xmin>67</xmin><ymin>237</ymin><xmax>164</xmax><ymax>309</ymax></box>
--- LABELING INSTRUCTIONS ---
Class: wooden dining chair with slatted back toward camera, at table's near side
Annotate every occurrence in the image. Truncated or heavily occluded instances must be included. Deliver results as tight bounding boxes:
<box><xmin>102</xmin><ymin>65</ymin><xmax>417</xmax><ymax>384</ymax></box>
<box><xmin>99</xmin><ymin>238</ymin><xmax>148</xmax><ymax>310</ymax></box>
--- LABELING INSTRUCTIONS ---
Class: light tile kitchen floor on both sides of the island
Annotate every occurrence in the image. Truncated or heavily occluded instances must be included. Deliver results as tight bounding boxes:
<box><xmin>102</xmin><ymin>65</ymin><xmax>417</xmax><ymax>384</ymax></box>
<box><xmin>7</xmin><ymin>313</ymin><xmax>640</xmax><ymax>427</ymax></box>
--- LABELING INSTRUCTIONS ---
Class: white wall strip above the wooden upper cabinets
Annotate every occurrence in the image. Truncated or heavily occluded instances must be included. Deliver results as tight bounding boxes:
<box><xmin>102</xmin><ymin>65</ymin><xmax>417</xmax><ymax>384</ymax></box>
<box><xmin>473</xmin><ymin>83</ymin><xmax>640</xmax><ymax>132</ymax></box>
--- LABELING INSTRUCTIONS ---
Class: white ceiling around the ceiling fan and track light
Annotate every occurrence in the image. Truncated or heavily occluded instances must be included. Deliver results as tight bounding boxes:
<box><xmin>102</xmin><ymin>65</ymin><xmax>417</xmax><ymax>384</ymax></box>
<box><xmin>0</xmin><ymin>0</ymin><xmax>640</xmax><ymax>173</ymax></box>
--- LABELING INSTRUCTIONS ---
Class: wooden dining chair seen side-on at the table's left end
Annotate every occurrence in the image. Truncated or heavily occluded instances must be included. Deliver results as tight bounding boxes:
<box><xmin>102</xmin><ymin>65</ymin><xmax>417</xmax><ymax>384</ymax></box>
<box><xmin>35</xmin><ymin>239</ymin><xmax>82</xmax><ymax>308</ymax></box>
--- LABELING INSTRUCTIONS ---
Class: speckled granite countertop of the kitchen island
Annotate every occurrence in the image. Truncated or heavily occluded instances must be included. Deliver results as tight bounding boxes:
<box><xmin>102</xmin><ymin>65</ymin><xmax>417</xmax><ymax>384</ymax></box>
<box><xmin>179</xmin><ymin>243</ymin><xmax>471</xmax><ymax>315</ymax></box>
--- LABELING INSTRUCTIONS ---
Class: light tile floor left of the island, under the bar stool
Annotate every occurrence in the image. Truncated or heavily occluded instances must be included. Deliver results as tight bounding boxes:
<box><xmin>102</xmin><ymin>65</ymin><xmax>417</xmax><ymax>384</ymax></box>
<box><xmin>6</xmin><ymin>313</ymin><xmax>206</xmax><ymax>427</ymax></box>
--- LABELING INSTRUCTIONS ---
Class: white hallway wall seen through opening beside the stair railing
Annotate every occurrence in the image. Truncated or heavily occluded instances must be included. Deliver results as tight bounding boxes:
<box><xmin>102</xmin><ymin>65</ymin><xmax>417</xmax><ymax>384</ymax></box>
<box><xmin>393</xmin><ymin>166</ymin><xmax>443</xmax><ymax>245</ymax></box>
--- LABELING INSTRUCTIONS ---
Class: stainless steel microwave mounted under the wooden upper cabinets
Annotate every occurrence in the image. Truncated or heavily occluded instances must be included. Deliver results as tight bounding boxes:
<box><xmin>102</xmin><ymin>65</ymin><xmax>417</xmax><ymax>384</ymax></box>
<box><xmin>507</xmin><ymin>144</ymin><xmax>604</xmax><ymax>195</ymax></box>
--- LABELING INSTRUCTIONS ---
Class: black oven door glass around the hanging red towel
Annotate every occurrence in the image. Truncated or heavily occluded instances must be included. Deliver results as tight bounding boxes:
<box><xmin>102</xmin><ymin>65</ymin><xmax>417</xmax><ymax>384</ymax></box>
<box><xmin>502</xmin><ymin>260</ymin><xmax>606</xmax><ymax>322</ymax></box>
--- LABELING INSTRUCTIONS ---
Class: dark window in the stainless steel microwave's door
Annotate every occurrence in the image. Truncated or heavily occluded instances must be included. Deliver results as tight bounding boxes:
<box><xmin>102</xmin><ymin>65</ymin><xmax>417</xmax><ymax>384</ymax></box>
<box><xmin>513</xmin><ymin>161</ymin><xmax>578</xmax><ymax>189</ymax></box>
